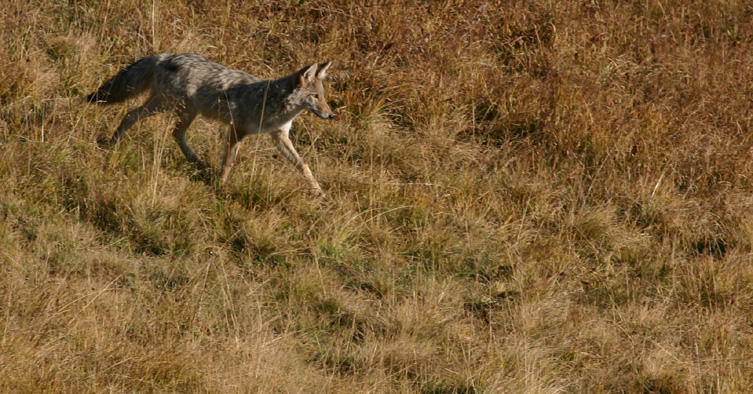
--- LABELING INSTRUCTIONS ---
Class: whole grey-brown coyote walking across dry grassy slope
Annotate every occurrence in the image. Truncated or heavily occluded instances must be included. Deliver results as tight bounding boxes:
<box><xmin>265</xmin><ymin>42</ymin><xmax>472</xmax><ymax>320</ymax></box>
<box><xmin>86</xmin><ymin>53</ymin><xmax>335</xmax><ymax>196</ymax></box>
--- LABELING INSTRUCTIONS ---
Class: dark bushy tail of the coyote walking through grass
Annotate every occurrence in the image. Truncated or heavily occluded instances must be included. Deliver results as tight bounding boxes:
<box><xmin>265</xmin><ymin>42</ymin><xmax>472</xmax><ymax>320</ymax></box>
<box><xmin>86</xmin><ymin>53</ymin><xmax>165</xmax><ymax>104</ymax></box>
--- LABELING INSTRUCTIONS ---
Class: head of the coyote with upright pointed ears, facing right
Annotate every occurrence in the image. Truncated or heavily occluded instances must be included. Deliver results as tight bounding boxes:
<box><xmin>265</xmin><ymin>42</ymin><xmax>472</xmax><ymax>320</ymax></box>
<box><xmin>292</xmin><ymin>62</ymin><xmax>335</xmax><ymax>119</ymax></box>
